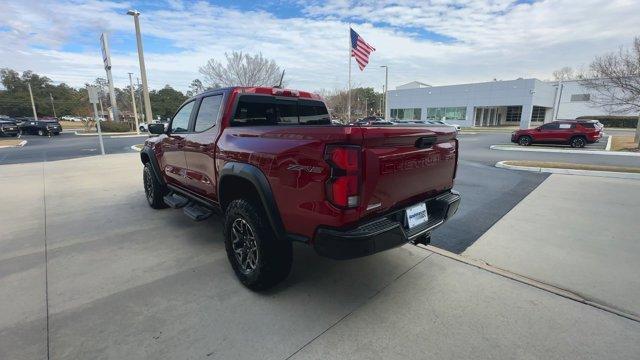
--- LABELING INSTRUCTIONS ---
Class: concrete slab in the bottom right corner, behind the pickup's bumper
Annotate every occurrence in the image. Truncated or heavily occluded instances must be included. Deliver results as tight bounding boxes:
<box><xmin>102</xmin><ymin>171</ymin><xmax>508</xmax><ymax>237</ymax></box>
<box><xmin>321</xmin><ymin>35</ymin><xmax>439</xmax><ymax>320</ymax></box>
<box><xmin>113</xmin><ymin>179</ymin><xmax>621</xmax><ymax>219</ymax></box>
<box><xmin>293</xmin><ymin>254</ymin><xmax>640</xmax><ymax>359</ymax></box>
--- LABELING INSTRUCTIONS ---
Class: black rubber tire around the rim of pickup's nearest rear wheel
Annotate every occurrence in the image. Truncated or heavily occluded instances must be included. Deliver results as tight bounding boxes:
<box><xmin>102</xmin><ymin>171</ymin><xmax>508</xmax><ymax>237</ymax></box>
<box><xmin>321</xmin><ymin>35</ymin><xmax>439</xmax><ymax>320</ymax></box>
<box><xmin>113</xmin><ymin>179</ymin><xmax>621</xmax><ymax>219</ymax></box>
<box><xmin>224</xmin><ymin>199</ymin><xmax>292</xmax><ymax>291</ymax></box>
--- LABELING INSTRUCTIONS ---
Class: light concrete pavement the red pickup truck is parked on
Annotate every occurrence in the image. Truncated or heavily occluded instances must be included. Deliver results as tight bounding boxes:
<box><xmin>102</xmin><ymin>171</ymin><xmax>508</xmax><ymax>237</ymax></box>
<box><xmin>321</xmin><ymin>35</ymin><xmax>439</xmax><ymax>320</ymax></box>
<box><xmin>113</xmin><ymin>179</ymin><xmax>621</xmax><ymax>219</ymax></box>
<box><xmin>0</xmin><ymin>154</ymin><xmax>640</xmax><ymax>359</ymax></box>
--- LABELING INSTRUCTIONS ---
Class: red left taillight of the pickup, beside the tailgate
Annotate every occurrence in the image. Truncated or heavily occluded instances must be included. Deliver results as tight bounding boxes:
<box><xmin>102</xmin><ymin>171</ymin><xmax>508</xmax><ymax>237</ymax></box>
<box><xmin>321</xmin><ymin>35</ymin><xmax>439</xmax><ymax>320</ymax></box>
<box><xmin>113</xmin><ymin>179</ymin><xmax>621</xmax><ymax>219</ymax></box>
<box><xmin>324</xmin><ymin>145</ymin><xmax>361</xmax><ymax>208</ymax></box>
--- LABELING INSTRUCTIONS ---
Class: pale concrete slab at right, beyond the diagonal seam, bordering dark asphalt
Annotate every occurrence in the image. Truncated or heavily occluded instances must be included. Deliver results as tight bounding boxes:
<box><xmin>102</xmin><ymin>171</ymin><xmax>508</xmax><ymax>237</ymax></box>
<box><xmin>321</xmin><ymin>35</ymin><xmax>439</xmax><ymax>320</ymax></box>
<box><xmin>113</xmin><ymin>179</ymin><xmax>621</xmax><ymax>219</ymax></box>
<box><xmin>463</xmin><ymin>175</ymin><xmax>640</xmax><ymax>316</ymax></box>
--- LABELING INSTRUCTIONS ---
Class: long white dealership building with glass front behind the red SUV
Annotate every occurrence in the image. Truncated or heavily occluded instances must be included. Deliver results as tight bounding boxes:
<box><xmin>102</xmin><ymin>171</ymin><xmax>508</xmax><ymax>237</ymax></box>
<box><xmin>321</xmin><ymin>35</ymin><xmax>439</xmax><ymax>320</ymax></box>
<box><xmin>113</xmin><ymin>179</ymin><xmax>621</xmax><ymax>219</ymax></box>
<box><xmin>386</xmin><ymin>79</ymin><xmax>637</xmax><ymax>128</ymax></box>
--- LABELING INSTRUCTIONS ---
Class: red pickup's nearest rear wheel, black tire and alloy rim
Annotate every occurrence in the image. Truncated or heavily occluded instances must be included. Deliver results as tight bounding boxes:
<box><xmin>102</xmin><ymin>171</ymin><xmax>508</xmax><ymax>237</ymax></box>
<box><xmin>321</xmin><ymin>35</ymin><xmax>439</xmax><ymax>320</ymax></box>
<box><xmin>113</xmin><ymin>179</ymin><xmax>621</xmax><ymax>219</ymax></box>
<box><xmin>224</xmin><ymin>199</ymin><xmax>292</xmax><ymax>290</ymax></box>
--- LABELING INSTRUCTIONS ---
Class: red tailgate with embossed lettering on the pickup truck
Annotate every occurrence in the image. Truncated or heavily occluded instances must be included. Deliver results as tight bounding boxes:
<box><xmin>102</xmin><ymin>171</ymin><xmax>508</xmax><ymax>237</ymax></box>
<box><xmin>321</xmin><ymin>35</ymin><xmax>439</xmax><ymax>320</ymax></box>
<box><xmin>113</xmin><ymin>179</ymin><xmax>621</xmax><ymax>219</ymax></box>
<box><xmin>361</xmin><ymin>126</ymin><xmax>458</xmax><ymax>216</ymax></box>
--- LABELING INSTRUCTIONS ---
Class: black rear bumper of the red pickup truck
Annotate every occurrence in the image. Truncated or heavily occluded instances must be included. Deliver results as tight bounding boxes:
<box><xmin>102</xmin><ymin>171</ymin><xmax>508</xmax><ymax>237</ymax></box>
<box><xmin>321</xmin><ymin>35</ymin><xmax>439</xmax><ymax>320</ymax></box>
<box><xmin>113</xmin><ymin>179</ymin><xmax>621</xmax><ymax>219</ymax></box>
<box><xmin>314</xmin><ymin>190</ymin><xmax>460</xmax><ymax>260</ymax></box>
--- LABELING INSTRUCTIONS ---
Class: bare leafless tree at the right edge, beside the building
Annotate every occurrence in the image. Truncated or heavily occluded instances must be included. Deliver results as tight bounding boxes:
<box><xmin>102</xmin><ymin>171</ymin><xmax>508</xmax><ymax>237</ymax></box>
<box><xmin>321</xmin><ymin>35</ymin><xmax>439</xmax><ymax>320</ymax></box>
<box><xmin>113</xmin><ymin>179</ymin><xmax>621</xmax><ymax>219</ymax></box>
<box><xmin>581</xmin><ymin>37</ymin><xmax>640</xmax><ymax>145</ymax></box>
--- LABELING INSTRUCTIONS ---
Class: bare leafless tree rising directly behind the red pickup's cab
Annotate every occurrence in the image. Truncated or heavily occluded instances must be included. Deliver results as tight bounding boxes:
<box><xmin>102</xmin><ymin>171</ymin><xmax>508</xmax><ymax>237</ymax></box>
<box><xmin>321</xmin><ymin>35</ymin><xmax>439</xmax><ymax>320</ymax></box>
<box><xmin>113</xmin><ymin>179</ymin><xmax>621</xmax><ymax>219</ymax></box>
<box><xmin>200</xmin><ymin>51</ymin><xmax>282</xmax><ymax>86</ymax></box>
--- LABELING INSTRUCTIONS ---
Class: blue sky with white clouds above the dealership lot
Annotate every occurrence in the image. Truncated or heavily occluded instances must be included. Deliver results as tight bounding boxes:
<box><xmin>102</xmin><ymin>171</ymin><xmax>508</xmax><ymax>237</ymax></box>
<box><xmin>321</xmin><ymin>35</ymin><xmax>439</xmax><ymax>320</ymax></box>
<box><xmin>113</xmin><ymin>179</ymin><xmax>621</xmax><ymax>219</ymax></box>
<box><xmin>0</xmin><ymin>0</ymin><xmax>640</xmax><ymax>91</ymax></box>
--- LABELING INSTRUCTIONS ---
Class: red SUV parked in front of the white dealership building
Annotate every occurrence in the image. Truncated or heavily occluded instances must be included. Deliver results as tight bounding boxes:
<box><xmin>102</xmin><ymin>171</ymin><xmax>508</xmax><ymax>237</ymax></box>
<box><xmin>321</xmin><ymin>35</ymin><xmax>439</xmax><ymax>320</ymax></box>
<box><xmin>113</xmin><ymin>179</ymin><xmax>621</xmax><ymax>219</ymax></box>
<box><xmin>511</xmin><ymin>120</ymin><xmax>604</xmax><ymax>148</ymax></box>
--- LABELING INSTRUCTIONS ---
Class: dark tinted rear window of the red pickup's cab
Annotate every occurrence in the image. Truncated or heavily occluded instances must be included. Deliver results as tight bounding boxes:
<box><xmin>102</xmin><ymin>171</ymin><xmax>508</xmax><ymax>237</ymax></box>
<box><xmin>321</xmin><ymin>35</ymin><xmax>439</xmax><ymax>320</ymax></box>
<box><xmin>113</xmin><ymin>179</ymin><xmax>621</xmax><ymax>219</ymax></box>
<box><xmin>231</xmin><ymin>95</ymin><xmax>331</xmax><ymax>126</ymax></box>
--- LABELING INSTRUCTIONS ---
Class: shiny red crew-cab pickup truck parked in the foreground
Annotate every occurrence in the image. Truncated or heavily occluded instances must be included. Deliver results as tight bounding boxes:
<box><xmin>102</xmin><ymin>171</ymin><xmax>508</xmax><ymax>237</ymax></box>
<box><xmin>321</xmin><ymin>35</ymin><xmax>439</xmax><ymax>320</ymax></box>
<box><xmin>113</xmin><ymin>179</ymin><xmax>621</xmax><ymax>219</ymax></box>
<box><xmin>140</xmin><ymin>87</ymin><xmax>460</xmax><ymax>290</ymax></box>
